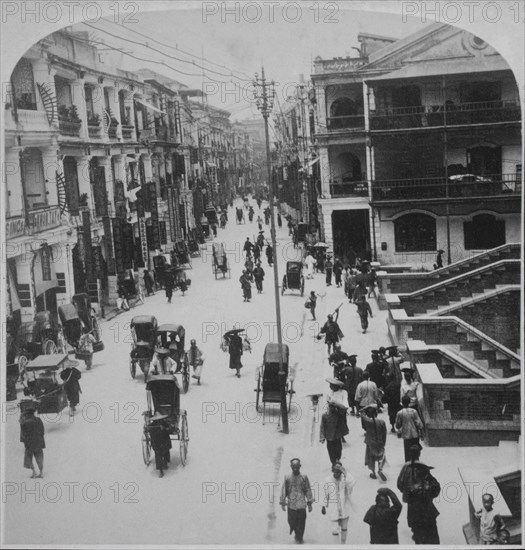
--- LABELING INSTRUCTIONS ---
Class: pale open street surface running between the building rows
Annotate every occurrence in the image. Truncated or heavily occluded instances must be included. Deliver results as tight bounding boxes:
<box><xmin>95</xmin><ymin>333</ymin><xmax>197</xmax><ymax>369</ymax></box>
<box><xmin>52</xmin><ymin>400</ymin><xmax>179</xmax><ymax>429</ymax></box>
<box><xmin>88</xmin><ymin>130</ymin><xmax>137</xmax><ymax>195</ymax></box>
<box><xmin>3</xmin><ymin>200</ymin><xmax>506</xmax><ymax>545</ymax></box>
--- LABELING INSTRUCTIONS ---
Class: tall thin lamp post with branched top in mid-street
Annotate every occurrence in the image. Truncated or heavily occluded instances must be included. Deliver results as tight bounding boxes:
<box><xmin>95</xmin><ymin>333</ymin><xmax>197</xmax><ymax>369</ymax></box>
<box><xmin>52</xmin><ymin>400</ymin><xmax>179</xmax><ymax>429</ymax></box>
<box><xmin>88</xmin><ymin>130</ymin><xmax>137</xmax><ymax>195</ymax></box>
<box><xmin>253</xmin><ymin>67</ymin><xmax>289</xmax><ymax>434</ymax></box>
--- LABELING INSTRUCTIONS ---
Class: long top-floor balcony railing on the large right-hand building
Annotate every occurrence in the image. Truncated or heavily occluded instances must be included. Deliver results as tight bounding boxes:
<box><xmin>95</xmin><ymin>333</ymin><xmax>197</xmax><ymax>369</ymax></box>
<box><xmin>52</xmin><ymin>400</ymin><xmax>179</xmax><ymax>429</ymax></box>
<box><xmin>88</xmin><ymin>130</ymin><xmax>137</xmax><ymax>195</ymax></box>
<box><xmin>370</xmin><ymin>101</ymin><xmax>521</xmax><ymax>130</ymax></box>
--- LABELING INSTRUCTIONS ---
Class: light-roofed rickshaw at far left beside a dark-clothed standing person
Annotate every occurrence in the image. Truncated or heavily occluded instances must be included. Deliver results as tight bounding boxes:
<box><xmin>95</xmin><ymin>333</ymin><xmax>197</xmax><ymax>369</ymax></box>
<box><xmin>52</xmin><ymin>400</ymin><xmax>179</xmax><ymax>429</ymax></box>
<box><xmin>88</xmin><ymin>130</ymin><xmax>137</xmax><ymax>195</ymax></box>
<box><xmin>20</xmin><ymin>353</ymin><xmax>68</xmax><ymax>414</ymax></box>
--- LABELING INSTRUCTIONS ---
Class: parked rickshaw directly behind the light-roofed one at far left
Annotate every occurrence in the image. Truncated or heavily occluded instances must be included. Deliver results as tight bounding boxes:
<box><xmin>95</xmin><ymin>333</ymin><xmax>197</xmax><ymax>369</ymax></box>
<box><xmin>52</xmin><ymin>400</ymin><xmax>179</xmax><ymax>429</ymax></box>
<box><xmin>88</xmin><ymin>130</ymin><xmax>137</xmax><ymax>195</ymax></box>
<box><xmin>15</xmin><ymin>311</ymin><xmax>66</xmax><ymax>379</ymax></box>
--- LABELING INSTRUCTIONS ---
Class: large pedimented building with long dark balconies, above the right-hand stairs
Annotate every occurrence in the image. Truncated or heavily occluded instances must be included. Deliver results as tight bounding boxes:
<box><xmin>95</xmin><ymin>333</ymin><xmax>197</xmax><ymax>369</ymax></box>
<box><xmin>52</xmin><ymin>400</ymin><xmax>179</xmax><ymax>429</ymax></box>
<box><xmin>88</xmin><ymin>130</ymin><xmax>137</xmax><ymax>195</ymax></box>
<box><xmin>312</xmin><ymin>24</ymin><xmax>522</xmax><ymax>268</ymax></box>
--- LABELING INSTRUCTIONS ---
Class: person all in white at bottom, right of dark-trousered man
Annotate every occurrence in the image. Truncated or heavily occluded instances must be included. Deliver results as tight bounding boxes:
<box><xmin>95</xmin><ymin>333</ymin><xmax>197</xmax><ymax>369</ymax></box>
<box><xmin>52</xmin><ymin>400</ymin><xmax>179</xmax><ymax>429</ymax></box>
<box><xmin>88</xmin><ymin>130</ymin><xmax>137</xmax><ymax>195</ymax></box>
<box><xmin>321</xmin><ymin>462</ymin><xmax>355</xmax><ymax>544</ymax></box>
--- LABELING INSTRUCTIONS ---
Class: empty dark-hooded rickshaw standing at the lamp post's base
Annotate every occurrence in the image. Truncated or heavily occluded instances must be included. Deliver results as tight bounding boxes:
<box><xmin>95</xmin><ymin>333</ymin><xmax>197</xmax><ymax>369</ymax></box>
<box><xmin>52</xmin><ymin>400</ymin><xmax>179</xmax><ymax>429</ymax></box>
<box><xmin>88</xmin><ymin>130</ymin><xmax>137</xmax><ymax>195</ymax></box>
<box><xmin>254</xmin><ymin>343</ymin><xmax>295</xmax><ymax>424</ymax></box>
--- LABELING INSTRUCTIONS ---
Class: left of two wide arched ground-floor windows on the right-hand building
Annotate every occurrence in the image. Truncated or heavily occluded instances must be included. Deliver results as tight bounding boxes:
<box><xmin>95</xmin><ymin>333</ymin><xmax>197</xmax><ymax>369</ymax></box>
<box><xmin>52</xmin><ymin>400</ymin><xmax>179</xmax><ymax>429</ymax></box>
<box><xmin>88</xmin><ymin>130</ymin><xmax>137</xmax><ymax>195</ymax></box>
<box><xmin>394</xmin><ymin>213</ymin><xmax>436</xmax><ymax>252</ymax></box>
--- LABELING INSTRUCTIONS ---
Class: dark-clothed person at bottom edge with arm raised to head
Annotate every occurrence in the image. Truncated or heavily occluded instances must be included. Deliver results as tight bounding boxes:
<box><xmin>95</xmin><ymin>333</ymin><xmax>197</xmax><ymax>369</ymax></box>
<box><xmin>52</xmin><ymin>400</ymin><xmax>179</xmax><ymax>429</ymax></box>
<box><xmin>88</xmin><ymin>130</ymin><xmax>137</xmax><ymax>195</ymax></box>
<box><xmin>363</xmin><ymin>487</ymin><xmax>403</xmax><ymax>544</ymax></box>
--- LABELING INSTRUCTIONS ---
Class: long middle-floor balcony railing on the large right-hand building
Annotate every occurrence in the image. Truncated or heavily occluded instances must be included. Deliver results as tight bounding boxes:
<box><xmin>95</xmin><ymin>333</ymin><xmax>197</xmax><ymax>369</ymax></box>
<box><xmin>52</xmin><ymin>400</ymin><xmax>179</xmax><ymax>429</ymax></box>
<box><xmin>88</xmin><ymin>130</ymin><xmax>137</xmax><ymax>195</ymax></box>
<box><xmin>372</xmin><ymin>174</ymin><xmax>521</xmax><ymax>202</ymax></box>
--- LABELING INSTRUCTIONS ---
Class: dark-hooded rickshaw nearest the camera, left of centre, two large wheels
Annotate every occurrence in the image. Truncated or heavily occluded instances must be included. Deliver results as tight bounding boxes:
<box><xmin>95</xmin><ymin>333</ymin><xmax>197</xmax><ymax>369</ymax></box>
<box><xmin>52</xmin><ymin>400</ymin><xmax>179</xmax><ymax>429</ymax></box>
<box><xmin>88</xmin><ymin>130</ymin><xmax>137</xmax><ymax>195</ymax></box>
<box><xmin>142</xmin><ymin>374</ymin><xmax>190</xmax><ymax>466</ymax></box>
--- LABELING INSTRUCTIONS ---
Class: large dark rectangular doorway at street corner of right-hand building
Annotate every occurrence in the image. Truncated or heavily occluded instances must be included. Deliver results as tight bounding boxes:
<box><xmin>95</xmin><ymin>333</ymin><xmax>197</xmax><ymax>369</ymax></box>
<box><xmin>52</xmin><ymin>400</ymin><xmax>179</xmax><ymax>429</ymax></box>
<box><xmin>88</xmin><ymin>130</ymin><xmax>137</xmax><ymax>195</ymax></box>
<box><xmin>332</xmin><ymin>209</ymin><xmax>372</xmax><ymax>265</ymax></box>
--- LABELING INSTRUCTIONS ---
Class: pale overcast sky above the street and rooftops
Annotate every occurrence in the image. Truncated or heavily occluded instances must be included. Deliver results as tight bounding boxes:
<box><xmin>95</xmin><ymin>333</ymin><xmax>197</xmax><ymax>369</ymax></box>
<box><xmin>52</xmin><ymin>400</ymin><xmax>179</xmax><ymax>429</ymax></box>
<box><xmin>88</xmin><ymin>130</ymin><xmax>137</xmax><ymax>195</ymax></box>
<box><xmin>75</xmin><ymin>2</ymin><xmax>429</xmax><ymax>120</ymax></box>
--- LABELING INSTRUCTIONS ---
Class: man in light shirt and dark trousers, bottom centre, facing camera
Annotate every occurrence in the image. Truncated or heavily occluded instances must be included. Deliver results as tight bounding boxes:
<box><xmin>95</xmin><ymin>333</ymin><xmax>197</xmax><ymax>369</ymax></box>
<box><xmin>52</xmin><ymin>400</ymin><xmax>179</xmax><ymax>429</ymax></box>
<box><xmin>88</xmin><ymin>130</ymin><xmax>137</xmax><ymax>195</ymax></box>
<box><xmin>279</xmin><ymin>458</ymin><xmax>314</xmax><ymax>544</ymax></box>
